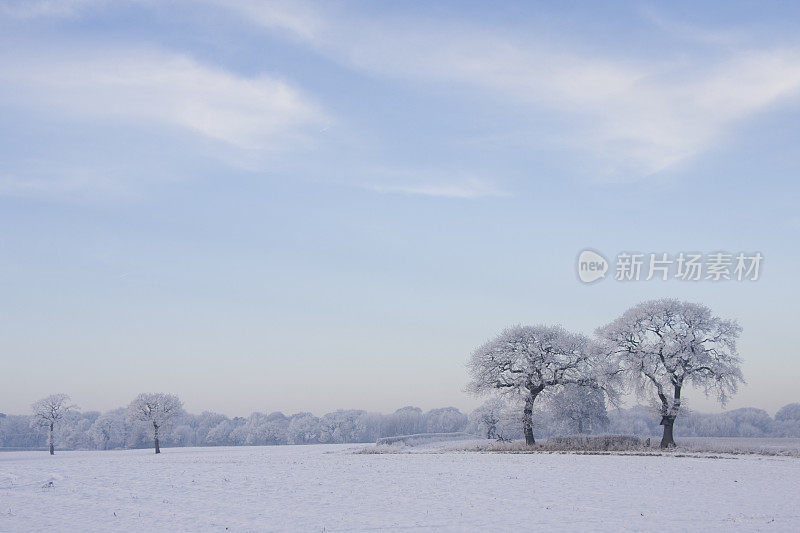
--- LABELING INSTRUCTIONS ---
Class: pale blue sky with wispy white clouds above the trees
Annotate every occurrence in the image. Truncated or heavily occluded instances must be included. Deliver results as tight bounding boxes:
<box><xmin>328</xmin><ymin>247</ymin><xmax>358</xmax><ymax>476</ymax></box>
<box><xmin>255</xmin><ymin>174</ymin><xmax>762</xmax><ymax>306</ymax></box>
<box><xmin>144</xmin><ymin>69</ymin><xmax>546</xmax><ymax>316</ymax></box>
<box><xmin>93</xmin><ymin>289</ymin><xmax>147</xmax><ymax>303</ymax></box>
<box><xmin>0</xmin><ymin>0</ymin><xmax>800</xmax><ymax>415</ymax></box>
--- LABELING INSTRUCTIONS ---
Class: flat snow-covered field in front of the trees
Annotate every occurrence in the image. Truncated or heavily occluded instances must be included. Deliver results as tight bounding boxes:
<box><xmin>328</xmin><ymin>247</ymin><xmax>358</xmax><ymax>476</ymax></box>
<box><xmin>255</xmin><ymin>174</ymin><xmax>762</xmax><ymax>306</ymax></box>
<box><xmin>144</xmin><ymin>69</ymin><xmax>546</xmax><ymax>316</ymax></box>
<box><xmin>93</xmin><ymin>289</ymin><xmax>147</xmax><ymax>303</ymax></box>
<box><xmin>0</xmin><ymin>445</ymin><xmax>800</xmax><ymax>531</ymax></box>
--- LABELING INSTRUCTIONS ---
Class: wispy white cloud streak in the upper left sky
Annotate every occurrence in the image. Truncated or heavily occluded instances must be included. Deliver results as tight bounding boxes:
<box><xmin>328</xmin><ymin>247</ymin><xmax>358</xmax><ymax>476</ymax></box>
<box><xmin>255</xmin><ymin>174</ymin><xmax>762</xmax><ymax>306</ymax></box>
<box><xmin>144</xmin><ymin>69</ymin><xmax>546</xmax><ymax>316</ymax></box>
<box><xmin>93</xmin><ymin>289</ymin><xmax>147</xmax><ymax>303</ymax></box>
<box><xmin>0</xmin><ymin>46</ymin><xmax>326</xmax><ymax>150</ymax></box>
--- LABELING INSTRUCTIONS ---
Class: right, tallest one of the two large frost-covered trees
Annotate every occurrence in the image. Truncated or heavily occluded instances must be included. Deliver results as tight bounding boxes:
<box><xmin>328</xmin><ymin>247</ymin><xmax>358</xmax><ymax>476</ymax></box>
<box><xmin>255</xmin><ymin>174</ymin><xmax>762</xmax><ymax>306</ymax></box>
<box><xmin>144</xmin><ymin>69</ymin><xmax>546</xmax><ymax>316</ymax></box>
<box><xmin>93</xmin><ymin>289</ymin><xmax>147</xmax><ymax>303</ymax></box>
<box><xmin>597</xmin><ymin>299</ymin><xmax>744</xmax><ymax>448</ymax></box>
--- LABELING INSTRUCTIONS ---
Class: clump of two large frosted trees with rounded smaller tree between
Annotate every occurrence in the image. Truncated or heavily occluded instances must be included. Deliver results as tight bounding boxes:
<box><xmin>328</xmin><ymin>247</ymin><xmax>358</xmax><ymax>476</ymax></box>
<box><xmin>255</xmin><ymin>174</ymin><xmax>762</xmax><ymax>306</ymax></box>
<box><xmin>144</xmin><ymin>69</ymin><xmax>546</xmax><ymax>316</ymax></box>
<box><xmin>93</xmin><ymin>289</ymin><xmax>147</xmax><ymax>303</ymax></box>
<box><xmin>468</xmin><ymin>299</ymin><xmax>744</xmax><ymax>448</ymax></box>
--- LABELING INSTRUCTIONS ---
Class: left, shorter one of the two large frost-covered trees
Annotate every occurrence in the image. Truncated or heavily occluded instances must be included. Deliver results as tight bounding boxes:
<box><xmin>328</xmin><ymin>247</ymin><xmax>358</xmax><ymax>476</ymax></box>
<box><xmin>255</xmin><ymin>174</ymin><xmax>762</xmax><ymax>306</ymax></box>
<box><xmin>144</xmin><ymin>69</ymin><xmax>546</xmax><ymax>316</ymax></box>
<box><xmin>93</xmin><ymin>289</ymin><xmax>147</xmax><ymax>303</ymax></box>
<box><xmin>468</xmin><ymin>326</ymin><xmax>603</xmax><ymax>445</ymax></box>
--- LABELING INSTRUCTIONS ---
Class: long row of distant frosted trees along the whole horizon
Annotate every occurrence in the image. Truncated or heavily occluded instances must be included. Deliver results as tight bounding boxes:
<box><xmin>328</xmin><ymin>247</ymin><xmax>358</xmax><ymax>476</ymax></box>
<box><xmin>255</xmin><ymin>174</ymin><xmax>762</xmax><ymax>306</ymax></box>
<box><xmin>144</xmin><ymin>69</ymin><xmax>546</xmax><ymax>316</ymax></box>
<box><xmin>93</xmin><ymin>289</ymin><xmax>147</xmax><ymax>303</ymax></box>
<box><xmin>0</xmin><ymin>396</ymin><xmax>800</xmax><ymax>450</ymax></box>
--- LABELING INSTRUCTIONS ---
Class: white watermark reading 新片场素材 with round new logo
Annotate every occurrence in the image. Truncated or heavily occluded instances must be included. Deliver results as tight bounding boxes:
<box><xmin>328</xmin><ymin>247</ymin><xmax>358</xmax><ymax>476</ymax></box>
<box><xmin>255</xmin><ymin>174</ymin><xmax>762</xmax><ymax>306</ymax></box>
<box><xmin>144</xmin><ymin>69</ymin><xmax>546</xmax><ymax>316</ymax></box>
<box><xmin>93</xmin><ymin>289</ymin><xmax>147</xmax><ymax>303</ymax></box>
<box><xmin>577</xmin><ymin>248</ymin><xmax>764</xmax><ymax>283</ymax></box>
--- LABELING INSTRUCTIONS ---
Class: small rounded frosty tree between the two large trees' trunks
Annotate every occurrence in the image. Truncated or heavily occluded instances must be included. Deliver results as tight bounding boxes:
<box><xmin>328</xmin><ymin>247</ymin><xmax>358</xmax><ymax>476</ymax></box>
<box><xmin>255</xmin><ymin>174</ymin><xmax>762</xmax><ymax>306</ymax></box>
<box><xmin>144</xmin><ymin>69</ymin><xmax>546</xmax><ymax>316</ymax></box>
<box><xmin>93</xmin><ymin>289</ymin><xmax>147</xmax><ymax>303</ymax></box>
<box><xmin>547</xmin><ymin>385</ymin><xmax>608</xmax><ymax>434</ymax></box>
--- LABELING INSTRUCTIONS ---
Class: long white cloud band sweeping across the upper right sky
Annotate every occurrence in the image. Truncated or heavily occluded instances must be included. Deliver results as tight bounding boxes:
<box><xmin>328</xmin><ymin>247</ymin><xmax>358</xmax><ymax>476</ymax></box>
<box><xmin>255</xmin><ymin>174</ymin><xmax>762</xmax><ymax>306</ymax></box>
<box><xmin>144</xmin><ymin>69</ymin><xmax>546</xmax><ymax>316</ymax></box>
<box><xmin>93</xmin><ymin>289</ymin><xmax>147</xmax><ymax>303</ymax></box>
<box><xmin>224</xmin><ymin>2</ymin><xmax>800</xmax><ymax>176</ymax></box>
